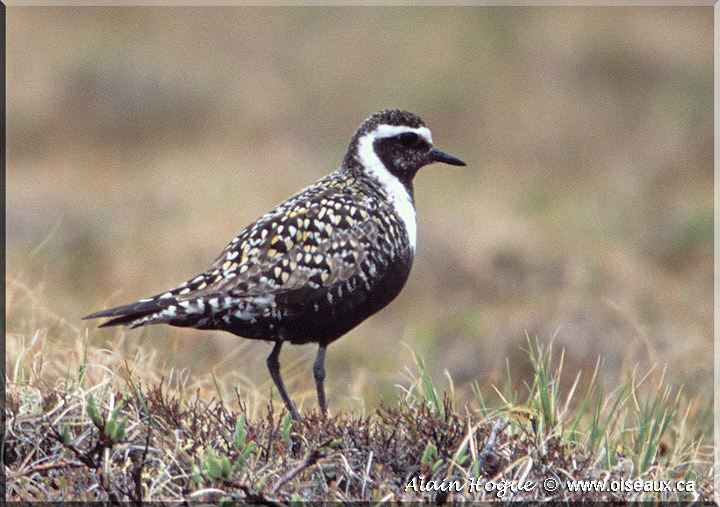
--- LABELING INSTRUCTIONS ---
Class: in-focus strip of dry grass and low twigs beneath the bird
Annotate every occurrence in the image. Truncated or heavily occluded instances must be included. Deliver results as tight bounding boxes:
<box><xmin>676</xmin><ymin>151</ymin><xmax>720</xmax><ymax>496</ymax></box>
<box><xmin>5</xmin><ymin>314</ymin><xmax>712</xmax><ymax>503</ymax></box>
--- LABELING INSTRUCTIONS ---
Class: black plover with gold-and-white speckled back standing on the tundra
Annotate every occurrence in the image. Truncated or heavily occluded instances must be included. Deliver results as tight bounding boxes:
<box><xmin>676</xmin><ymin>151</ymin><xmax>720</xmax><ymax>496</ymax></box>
<box><xmin>83</xmin><ymin>109</ymin><xmax>466</xmax><ymax>421</ymax></box>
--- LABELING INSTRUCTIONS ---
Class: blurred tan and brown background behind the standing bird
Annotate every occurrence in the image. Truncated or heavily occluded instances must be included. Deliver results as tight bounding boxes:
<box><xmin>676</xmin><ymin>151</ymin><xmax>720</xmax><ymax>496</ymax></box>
<box><xmin>6</xmin><ymin>7</ymin><xmax>713</xmax><ymax>420</ymax></box>
